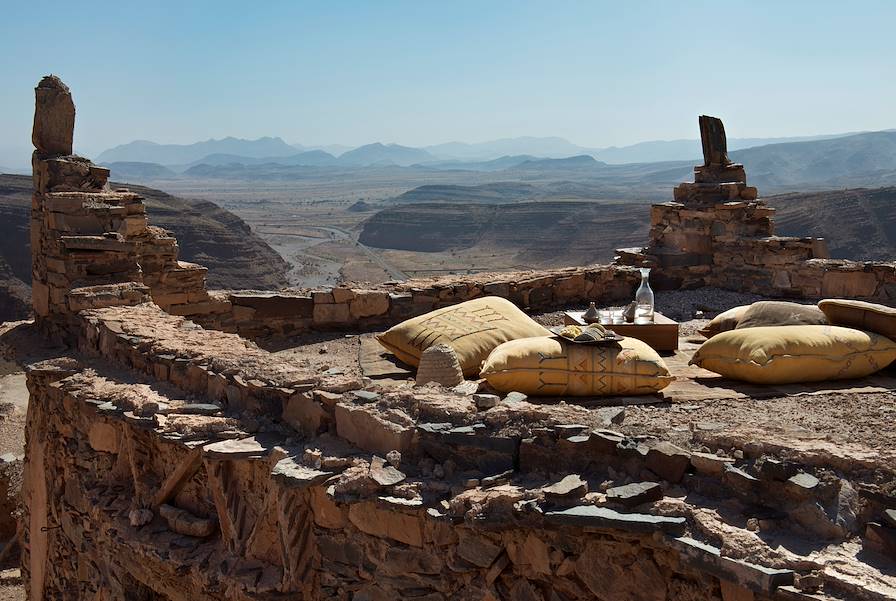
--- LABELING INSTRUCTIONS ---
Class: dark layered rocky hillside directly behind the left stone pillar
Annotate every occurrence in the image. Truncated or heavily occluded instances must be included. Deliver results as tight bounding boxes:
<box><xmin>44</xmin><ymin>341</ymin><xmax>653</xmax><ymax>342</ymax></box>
<box><xmin>0</xmin><ymin>175</ymin><xmax>288</xmax><ymax>321</ymax></box>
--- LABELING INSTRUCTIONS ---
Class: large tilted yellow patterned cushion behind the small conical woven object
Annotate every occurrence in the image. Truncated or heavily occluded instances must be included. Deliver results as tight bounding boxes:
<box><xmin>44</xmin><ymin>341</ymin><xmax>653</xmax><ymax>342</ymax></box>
<box><xmin>377</xmin><ymin>296</ymin><xmax>550</xmax><ymax>376</ymax></box>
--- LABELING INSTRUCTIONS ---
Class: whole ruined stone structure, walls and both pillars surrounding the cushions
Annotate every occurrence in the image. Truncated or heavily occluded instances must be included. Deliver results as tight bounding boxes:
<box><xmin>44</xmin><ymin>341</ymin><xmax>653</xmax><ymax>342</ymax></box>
<box><xmin>22</xmin><ymin>77</ymin><xmax>896</xmax><ymax>601</ymax></box>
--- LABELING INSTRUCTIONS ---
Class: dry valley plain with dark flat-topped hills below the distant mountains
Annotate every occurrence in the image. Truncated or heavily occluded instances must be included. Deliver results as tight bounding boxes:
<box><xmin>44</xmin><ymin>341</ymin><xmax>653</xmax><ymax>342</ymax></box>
<box><xmin>157</xmin><ymin>169</ymin><xmax>896</xmax><ymax>287</ymax></box>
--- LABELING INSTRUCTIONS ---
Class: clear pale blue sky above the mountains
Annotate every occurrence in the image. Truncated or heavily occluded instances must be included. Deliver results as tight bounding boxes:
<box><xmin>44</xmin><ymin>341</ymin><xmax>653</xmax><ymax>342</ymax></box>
<box><xmin>0</xmin><ymin>0</ymin><xmax>896</xmax><ymax>167</ymax></box>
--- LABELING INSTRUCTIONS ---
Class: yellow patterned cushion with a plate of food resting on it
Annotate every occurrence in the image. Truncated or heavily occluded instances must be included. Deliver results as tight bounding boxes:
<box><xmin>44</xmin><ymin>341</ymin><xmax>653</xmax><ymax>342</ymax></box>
<box><xmin>480</xmin><ymin>337</ymin><xmax>674</xmax><ymax>396</ymax></box>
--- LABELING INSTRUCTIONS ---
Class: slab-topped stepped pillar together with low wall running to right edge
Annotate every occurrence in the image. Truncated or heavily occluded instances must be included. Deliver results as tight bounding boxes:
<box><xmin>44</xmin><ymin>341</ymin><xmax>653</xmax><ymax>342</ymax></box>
<box><xmin>616</xmin><ymin>117</ymin><xmax>896</xmax><ymax>302</ymax></box>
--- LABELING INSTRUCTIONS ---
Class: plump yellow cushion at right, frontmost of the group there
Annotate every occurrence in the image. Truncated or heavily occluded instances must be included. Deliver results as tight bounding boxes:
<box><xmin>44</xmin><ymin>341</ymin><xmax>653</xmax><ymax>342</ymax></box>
<box><xmin>691</xmin><ymin>325</ymin><xmax>896</xmax><ymax>384</ymax></box>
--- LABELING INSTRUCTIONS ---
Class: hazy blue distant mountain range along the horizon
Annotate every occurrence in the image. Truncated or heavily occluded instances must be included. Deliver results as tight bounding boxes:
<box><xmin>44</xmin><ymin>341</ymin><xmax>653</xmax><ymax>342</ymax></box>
<box><xmin>89</xmin><ymin>130</ymin><xmax>896</xmax><ymax>193</ymax></box>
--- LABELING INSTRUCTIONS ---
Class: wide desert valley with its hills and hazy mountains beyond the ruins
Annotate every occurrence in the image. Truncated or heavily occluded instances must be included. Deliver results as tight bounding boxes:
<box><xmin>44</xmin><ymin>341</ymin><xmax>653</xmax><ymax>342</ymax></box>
<box><xmin>7</xmin><ymin>126</ymin><xmax>896</xmax><ymax>310</ymax></box>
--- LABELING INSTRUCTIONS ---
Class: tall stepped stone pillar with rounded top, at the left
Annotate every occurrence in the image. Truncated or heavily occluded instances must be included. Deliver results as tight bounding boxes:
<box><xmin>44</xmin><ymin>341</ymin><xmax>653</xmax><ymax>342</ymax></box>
<box><xmin>31</xmin><ymin>75</ymin><xmax>216</xmax><ymax>321</ymax></box>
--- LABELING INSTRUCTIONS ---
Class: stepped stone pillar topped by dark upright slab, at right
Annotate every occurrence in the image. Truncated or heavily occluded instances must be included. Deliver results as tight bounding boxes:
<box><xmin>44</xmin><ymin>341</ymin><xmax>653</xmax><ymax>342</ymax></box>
<box><xmin>617</xmin><ymin>116</ymin><xmax>828</xmax><ymax>296</ymax></box>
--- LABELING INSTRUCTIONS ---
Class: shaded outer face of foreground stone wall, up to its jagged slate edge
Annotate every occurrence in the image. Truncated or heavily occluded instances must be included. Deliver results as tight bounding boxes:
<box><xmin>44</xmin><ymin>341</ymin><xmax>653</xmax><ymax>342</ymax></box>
<box><xmin>24</xmin><ymin>340</ymin><xmax>793</xmax><ymax>601</ymax></box>
